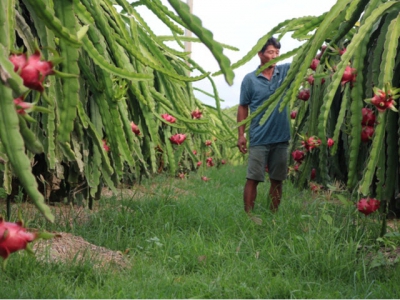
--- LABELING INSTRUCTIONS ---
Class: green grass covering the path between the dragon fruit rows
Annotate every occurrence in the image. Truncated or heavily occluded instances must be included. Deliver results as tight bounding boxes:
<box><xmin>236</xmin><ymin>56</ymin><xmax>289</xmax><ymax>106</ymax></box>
<box><xmin>0</xmin><ymin>166</ymin><xmax>400</xmax><ymax>298</ymax></box>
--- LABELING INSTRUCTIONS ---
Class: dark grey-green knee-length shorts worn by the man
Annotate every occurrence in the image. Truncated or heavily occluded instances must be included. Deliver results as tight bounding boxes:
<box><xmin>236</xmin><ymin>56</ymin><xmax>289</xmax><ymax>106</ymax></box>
<box><xmin>246</xmin><ymin>142</ymin><xmax>289</xmax><ymax>181</ymax></box>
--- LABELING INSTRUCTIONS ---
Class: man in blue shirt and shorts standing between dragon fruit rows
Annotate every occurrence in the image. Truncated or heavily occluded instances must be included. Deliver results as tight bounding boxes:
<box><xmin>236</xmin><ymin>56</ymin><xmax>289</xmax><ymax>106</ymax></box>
<box><xmin>237</xmin><ymin>37</ymin><xmax>290</xmax><ymax>214</ymax></box>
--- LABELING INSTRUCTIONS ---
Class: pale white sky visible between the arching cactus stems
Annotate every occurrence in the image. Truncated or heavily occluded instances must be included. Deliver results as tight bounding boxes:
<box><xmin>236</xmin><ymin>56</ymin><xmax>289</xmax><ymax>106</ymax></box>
<box><xmin>133</xmin><ymin>0</ymin><xmax>337</xmax><ymax>108</ymax></box>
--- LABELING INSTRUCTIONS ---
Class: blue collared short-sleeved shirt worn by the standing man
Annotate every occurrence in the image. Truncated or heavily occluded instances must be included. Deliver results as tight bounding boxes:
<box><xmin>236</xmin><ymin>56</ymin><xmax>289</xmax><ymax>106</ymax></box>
<box><xmin>240</xmin><ymin>63</ymin><xmax>290</xmax><ymax>146</ymax></box>
